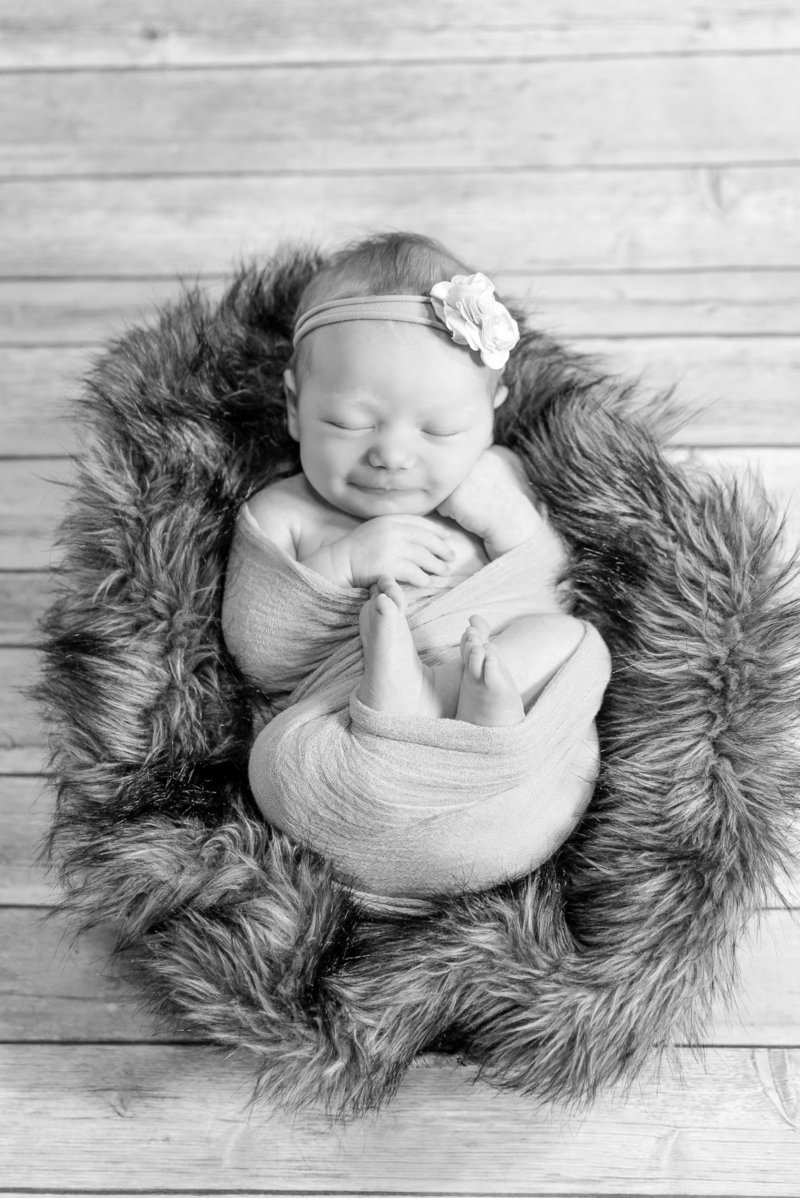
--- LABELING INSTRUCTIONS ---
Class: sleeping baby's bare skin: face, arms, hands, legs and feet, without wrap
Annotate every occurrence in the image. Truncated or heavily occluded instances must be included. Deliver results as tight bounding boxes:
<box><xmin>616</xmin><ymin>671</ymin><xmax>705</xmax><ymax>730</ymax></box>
<box><xmin>248</xmin><ymin>306</ymin><xmax>583</xmax><ymax>725</ymax></box>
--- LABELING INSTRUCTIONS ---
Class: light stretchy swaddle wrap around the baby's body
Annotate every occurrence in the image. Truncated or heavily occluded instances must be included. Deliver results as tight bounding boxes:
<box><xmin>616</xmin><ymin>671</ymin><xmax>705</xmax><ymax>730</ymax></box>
<box><xmin>223</xmin><ymin>506</ymin><xmax>610</xmax><ymax>910</ymax></box>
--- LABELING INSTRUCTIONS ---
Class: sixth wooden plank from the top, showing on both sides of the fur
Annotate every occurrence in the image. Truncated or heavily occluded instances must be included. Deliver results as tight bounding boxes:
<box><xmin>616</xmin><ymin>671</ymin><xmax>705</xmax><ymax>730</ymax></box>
<box><xmin>0</xmin><ymin>447</ymin><xmax>800</xmax><ymax>570</ymax></box>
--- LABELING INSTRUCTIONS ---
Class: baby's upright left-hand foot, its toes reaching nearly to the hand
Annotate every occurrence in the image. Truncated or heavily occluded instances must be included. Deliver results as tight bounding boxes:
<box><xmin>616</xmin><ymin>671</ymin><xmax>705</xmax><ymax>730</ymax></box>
<box><xmin>357</xmin><ymin>577</ymin><xmax>442</xmax><ymax>719</ymax></box>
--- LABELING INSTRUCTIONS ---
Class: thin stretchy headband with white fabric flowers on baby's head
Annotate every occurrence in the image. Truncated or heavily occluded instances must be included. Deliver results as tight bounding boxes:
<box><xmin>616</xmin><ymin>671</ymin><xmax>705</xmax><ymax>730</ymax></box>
<box><xmin>292</xmin><ymin>273</ymin><xmax>520</xmax><ymax>370</ymax></box>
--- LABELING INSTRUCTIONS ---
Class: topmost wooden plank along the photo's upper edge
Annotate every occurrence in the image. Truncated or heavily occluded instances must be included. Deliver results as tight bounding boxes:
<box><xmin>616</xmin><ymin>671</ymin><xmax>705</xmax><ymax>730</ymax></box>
<box><xmin>0</xmin><ymin>0</ymin><xmax>800</xmax><ymax>68</ymax></box>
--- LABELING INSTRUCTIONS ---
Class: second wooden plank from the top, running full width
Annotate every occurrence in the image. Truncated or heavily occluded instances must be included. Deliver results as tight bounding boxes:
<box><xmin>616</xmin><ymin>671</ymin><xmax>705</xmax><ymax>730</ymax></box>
<box><xmin>6</xmin><ymin>54</ymin><xmax>800</xmax><ymax>179</ymax></box>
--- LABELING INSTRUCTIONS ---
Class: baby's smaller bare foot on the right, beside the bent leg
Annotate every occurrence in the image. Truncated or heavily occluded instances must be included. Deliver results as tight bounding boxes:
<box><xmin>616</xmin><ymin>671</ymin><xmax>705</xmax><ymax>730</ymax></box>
<box><xmin>455</xmin><ymin>616</ymin><xmax>525</xmax><ymax>728</ymax></box>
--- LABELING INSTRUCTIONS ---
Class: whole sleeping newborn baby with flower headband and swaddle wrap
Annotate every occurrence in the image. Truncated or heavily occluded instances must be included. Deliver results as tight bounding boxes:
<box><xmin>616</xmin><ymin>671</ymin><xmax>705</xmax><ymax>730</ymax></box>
<box><xmin>223</xmin><ymin>228</ymin><xmax>608</xmax><ymax>907</ymax></box>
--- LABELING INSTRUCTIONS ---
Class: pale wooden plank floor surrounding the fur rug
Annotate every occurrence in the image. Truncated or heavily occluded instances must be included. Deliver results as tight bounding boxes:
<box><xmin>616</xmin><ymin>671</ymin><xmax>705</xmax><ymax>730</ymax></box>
<box><xmin>0</xmin><ymin>0</ymin><xmax>800</xmax><ymax>1198</ymax></box>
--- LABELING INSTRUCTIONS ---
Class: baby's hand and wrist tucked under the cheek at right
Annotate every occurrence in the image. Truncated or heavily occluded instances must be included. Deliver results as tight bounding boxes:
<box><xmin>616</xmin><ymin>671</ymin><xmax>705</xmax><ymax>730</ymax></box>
<box><xmin>436</xmin><ymin>446</ymin><xmax>541</xmax><ymax>559</ymax></box>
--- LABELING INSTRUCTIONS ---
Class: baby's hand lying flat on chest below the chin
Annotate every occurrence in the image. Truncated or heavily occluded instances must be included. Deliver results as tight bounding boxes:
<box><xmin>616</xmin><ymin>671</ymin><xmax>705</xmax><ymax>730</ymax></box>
<box><xmin>331</xmin><ymin>515</ymin><xmax>455</xmax><ymax>587</ymax></box>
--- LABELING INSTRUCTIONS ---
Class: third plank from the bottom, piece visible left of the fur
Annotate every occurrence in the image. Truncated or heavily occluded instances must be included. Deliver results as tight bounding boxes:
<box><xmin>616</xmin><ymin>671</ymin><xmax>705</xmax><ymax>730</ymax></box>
<box><xmin>0</xmin><ymin>776</ymin><xmax>55</xmax><ymax>907</ymax></box>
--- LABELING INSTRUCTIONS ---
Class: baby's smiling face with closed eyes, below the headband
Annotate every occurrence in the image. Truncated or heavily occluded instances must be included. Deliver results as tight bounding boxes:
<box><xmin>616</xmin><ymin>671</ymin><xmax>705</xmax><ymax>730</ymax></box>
<box><xmin>285</xmin><ymin>321</ymin><xmax>507</xmax><ymax>520</ymax></box>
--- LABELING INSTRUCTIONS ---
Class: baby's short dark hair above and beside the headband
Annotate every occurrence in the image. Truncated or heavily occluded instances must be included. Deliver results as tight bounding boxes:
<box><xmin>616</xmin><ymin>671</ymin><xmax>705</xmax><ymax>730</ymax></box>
<box><xmin>289</xmin><ymin>232</ymin><xmax>474</xmax><ymax>380</ymax></box>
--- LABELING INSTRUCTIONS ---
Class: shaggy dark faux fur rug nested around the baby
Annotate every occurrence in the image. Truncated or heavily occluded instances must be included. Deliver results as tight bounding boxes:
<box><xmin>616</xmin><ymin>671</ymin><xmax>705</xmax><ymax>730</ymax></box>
<box><xmin>38</xmin><ymin>247</ymin><xmax>800</xmax><ymax>1118</ymax></box>
